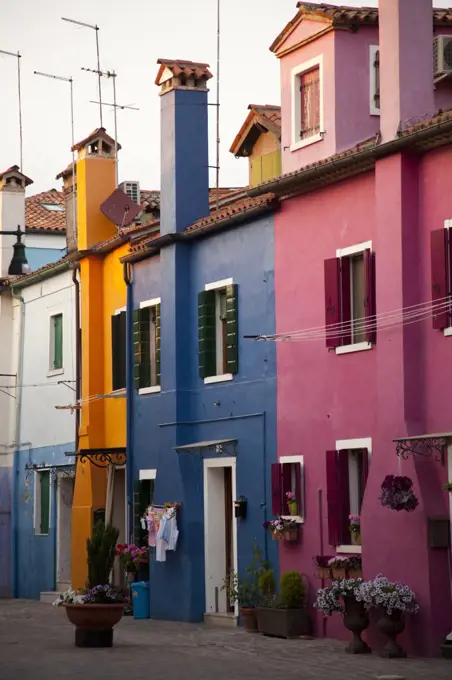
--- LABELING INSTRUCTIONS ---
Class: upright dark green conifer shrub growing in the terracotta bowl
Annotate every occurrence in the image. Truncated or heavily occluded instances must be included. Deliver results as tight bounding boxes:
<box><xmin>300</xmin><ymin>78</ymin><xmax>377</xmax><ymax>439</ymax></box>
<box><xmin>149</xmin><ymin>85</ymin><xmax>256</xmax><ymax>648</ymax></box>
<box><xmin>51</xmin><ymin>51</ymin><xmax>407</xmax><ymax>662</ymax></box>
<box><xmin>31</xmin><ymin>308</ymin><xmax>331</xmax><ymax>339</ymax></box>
<box><xmin>86</xmin><ymin>520</ymin><xmax>119</xmax><ymax>588</ymax></box>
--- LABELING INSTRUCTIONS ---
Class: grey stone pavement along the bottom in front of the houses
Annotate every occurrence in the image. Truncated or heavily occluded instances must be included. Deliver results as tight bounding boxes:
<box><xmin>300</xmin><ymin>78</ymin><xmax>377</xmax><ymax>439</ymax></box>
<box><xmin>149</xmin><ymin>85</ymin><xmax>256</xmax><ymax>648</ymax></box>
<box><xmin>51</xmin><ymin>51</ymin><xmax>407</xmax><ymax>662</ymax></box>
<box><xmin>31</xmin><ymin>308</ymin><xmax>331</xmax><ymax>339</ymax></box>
<box><xmin>0</xmin><ymin>600</ymin><xmax>452</xmax><ymax>680</ymax></box>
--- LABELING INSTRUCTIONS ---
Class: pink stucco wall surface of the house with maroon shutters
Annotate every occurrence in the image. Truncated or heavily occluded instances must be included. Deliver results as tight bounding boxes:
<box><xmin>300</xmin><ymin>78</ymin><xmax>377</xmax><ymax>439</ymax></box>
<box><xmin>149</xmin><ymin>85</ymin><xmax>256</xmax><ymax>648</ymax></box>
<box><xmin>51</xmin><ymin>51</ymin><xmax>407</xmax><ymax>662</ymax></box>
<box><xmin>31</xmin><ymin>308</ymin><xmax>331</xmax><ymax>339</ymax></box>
<box><xmin>275</xmin><ymin>150</ymin><xmax>452</xmax><ymax>654</ymax></box>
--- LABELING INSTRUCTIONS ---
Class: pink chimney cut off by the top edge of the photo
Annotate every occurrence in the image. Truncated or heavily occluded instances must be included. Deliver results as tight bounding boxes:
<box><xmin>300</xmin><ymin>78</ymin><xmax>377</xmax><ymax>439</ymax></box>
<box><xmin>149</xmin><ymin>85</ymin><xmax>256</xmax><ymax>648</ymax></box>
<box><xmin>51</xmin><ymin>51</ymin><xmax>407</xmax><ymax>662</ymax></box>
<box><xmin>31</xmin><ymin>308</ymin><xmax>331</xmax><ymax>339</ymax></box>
<box><xmin>378</xmin><ymin>0</ymin><xmax>435</xmax><ymax>142</ymax></box>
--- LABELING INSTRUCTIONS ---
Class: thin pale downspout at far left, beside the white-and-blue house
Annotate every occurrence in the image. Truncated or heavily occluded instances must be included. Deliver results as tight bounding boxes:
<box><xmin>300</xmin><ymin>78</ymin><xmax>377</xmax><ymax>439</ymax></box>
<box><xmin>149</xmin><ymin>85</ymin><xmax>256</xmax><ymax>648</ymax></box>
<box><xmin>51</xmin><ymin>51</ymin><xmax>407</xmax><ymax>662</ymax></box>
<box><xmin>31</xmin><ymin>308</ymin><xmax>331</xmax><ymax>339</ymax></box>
<box><xmin>11</xmin><ymin>288</ymin><xmax>25</xmax><ymax>597</ymax></box>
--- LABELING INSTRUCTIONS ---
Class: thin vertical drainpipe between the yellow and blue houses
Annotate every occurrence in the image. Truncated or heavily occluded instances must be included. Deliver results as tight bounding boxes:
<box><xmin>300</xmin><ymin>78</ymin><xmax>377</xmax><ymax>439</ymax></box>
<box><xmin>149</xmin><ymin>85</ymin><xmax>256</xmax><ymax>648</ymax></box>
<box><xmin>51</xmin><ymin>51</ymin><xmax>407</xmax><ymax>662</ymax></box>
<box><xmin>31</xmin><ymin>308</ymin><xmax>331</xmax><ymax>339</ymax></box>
<box><xmin>123</xmin><ymin>262</ymin><xmax>134</xmax><ymax>542</ymax></box>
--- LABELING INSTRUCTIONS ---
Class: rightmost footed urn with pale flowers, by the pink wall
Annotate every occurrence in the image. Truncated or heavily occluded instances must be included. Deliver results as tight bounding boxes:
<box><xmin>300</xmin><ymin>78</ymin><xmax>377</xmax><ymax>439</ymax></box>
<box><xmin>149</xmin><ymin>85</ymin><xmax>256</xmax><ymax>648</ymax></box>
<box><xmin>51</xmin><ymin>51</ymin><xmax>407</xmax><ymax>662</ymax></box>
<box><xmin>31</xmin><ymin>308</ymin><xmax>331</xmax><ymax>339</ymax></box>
<box><xmin>362</xmin><ymin>574</ymin><xmax>419</xmax><ymax>659</ymax></box>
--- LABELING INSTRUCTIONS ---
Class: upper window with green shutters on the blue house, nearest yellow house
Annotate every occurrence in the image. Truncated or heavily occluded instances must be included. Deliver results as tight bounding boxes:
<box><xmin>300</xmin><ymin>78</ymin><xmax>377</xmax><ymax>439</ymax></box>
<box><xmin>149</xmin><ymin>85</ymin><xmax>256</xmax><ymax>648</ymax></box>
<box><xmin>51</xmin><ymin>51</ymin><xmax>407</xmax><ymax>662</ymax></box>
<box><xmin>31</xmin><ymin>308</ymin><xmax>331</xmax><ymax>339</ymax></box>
<box><xmin>133</xmin><ymin>298</ymin><xmax>160</xmax><ymax>393</ymax></box>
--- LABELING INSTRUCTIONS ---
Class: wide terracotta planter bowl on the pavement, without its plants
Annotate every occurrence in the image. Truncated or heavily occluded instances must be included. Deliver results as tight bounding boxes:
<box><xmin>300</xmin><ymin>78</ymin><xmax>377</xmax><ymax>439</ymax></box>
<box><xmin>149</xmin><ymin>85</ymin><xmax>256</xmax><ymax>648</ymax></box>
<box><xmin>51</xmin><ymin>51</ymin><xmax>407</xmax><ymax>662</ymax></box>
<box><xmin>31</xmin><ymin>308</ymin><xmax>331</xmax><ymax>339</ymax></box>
<box><xmin>64</xmin><ymin>604</ymin><xmax>124</xmax><ymax>647</ymax></box>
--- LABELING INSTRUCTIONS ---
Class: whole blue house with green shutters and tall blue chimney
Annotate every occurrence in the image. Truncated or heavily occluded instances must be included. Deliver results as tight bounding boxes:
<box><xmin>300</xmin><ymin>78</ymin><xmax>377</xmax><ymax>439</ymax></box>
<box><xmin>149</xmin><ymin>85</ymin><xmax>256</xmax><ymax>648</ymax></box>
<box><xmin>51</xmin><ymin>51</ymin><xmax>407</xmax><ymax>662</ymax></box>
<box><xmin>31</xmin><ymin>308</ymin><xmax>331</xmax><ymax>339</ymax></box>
<box><xmin>125</xmin><ymin>60</ymin><xmax>277</xmax><ymax>621</ymax></box>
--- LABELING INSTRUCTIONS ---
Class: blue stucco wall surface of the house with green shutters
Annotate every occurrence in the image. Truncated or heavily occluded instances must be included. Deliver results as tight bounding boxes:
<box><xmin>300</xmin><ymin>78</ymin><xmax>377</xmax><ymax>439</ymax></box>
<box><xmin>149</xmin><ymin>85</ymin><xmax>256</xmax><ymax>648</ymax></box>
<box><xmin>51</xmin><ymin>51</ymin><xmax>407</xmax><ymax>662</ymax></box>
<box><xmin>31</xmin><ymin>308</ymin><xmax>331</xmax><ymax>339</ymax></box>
<box><xmin>133</xmin><ymin>216</ymin><xmax>278</xmax><ymax>621</ymax></box>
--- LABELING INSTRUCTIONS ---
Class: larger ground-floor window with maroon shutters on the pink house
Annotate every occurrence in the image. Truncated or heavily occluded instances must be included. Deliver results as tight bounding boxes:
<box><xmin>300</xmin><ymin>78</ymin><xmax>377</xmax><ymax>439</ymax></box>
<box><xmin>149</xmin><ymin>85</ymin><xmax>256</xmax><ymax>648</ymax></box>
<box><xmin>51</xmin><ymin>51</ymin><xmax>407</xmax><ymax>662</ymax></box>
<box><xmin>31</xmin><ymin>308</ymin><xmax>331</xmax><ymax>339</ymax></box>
<box><xmin>326</xmin><ymin>440</ymin><xmax>370</xmax><ymax>546</ymax></box>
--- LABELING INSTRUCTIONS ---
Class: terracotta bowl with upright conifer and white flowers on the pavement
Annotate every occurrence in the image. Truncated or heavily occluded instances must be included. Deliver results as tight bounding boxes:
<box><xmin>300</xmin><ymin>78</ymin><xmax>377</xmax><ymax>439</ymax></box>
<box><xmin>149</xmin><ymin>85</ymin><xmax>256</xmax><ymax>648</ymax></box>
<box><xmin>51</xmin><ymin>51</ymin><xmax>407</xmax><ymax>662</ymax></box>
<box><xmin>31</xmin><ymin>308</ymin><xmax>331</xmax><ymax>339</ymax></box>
<box><xmin>54</xmin><ymin>521</ymin><xmax>125</xmax><ymax>647</ymax></box>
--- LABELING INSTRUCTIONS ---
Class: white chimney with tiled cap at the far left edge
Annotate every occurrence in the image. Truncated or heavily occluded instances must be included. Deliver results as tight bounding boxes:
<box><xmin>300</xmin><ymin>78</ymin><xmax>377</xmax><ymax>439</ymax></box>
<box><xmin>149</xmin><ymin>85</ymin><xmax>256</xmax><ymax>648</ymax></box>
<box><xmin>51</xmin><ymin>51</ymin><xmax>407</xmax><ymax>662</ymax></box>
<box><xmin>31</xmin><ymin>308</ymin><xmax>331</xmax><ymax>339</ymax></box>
<box><xmin>0</xmin><ymin>165</ymin><xmax>33</xmax><ymax>278</ymax></box>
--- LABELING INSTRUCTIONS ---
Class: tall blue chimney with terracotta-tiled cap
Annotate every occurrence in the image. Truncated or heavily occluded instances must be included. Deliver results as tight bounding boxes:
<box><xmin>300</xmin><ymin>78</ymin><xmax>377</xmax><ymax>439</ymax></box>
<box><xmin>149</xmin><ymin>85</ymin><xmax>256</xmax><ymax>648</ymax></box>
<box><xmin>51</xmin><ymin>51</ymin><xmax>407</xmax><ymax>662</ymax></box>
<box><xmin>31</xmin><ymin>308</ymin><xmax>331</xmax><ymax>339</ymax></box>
<box><xmin>155</xmin><ymin>59</ymin><xmax>212</xmax><ymax>236</ymax></box>
